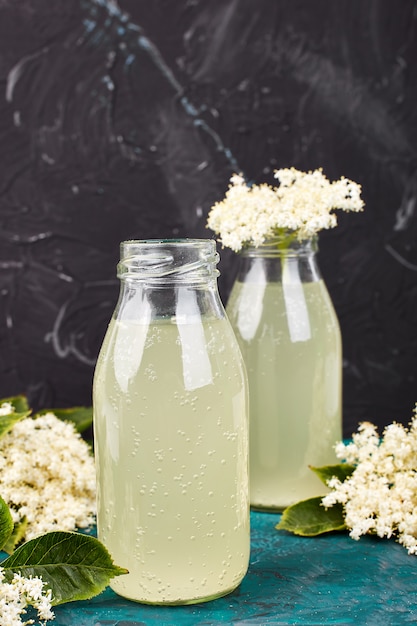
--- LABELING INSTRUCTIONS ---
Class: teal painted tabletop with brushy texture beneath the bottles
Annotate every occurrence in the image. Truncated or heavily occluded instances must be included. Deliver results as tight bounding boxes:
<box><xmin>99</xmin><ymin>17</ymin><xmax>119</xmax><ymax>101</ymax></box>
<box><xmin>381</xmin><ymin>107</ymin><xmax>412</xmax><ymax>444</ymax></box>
<box><xmin>51</xmin><ymin>513</ymin><xmax>417</xmax><ymax>626</ymax></box>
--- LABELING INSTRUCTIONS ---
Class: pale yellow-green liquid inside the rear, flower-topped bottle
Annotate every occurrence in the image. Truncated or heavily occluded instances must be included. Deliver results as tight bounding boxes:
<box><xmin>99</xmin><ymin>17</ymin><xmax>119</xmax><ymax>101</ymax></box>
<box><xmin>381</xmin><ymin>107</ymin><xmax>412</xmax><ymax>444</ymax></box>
<box><xmin>227</xmin><ymin>281</ymin><xmax>342</xmax><ymax>510</ymax></box>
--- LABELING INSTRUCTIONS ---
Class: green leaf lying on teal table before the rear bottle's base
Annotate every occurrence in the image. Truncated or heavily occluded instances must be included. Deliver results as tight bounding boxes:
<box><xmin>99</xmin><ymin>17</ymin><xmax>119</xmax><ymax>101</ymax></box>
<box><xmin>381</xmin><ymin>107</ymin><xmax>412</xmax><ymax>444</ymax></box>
<box><xmin>275</xmin><ymin>496</ymin><xmax>346</xmax><ymax>537</ymax></box>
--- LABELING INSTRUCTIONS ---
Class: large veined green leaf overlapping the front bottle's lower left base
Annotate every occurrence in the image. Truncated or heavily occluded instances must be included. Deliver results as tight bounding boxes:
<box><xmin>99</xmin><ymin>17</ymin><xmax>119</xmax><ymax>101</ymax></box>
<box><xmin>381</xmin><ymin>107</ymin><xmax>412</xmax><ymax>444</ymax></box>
<box><xmin>1</xmin><ymin>532</ymin><xmax>128</xmax><ymax>605</ymax></box>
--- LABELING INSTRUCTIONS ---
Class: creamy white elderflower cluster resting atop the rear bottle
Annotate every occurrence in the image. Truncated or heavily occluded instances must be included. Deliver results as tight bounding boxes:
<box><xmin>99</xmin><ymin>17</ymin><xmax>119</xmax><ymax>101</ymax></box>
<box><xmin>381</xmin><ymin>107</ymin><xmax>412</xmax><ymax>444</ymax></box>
<box><xmin>207</xmin><ymin>167</ymin><xmax>364</xmax><ymax>252</ymax></box>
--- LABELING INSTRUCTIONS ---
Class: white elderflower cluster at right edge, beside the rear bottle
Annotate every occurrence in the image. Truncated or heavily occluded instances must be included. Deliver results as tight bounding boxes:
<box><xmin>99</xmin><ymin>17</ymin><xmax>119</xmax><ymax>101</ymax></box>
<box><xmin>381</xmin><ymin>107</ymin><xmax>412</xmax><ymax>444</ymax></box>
<box><xmin>322</xmin><ymin>406</ymin><xmax>417</xmax><ymax>554</ymax></box>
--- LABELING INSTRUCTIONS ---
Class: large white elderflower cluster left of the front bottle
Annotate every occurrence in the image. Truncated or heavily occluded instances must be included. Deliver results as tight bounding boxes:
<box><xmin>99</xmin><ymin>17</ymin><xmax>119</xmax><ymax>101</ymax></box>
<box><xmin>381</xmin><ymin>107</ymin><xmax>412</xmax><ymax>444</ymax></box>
<box><xmin>0</xmin><ymin>403</ymin><xmax>96</xmax><ymax>540</ymax></box>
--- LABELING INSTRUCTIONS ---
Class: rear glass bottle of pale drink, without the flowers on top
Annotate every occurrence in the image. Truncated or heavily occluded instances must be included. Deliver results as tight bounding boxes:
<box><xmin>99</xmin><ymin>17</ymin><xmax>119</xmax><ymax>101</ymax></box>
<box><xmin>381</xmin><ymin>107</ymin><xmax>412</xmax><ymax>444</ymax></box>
<box><xmin>226</xmin><ymin>237</ymin><xmax>342</xmax><ymax>510</ymax></box>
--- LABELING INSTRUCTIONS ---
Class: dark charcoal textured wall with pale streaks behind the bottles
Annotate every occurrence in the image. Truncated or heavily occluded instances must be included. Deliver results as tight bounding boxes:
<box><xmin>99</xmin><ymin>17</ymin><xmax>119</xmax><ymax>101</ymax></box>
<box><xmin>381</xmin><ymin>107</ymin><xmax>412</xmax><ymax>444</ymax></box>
<box><xmin>0</xmin><ymin>0</ymin><xmax>417</xmax><ymax>434</ymax></box>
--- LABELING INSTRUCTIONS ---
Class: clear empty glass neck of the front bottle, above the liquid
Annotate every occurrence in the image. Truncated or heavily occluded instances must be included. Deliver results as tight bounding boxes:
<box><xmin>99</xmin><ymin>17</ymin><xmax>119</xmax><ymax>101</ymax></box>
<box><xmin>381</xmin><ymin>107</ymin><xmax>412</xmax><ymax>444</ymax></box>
<box><xmin>115</xmin><ymin>239</ymin><xmax>224</xmax><ymax>322</ymax></box>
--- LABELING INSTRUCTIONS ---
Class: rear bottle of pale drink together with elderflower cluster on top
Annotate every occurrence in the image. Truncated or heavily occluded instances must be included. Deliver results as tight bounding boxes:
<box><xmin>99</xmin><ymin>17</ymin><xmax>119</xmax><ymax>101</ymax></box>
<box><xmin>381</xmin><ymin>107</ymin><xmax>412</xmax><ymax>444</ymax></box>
<box><xmin>207</xmin><ymin>168</ymin><xmax>363</xmax><ymax>510</ymax></box>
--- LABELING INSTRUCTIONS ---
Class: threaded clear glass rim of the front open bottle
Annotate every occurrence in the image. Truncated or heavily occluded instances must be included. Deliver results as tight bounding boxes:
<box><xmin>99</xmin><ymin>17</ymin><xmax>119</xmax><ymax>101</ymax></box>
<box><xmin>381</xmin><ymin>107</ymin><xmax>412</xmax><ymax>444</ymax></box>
<box><xmin>117</xmin><ymin>239</ymin><xmax>219</xmax><ymax>283</ymax></box>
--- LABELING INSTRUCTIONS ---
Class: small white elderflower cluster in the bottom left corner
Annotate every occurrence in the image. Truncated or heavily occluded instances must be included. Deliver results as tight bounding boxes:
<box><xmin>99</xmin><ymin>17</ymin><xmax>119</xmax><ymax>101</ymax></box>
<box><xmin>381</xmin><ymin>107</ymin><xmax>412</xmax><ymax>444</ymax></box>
<box><xmin>0</xmin><ymin>567</ymin><xmax>54</xmax><ymax>626</ymax></box>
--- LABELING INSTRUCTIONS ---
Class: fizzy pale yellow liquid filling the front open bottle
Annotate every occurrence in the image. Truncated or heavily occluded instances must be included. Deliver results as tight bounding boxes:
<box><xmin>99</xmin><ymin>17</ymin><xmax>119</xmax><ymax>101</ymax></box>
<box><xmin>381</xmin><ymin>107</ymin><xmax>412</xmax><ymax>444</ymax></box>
<box><xmin>94</xmin><ymin>320</ymin><xmax>249</xmax><ymax>604</ymax></box>
